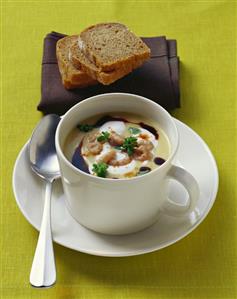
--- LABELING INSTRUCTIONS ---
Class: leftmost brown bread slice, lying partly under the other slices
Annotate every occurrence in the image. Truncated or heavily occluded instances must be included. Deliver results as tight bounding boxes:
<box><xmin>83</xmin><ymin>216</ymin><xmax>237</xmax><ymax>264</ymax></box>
<box><xmin>56</xmin><ymin>35</ymin><xmax>98</xmax><ymax>89</ymax></box>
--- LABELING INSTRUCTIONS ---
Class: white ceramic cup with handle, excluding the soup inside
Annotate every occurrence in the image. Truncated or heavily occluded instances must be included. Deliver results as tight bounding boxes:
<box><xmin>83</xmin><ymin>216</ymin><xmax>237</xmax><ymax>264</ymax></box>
<box><xmin>56</xmin><ymin>93</ymin><xmax>199</xmax><ymax>234</ymax></box>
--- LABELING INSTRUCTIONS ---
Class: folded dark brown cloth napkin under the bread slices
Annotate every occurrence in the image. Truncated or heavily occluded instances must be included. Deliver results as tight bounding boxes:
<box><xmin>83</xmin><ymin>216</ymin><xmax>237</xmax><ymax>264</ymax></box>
<box><xmin>37</xmin><ymin>32</ymin><xmax>180</xmax><ymax>114</ymax></box>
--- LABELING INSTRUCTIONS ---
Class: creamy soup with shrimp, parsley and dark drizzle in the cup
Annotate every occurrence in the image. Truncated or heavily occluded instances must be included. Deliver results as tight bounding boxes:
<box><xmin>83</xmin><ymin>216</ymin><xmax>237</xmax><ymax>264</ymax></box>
<box><xmin>63</xmin><ymin>113</ymin><xmax>170</xmax><ymax>179</ymax></box>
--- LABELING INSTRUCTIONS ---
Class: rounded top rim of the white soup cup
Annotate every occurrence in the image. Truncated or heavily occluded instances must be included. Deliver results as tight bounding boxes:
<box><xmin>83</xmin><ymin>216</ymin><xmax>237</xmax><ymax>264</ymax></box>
<box><xmin>55</xmin><ymin>92</ymin><xmax>179</xmax><ymax>183</ymax></box>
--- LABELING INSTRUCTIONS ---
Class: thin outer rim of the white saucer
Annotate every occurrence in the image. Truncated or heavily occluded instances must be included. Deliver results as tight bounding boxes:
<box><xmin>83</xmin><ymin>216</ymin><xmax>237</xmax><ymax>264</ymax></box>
<box><xmin>12</xmin><ymin>117</ymin><xmax>219</xmax><ymax>257</ymax></box>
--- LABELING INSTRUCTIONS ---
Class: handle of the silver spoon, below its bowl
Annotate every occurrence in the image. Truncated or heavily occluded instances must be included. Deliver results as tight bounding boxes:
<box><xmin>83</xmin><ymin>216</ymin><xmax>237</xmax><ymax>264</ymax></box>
<box><xmin>30</xmin><ymin>181</ymin><xmax>56</xmax><ymax>287</ymax></box>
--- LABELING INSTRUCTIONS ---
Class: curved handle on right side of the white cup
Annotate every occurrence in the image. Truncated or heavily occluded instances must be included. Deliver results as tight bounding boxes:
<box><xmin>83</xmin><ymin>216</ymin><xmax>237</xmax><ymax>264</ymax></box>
<box><xmin>162</xmin><ymin>165</ymin><xmax>200</xmax><ymax>217</ymax></box>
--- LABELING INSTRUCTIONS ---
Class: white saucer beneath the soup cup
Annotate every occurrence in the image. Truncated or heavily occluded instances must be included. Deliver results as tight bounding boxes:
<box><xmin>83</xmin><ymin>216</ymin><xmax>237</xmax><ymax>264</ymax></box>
<box><xmin>13</xmin><ymin>119</ymin><xmax>218</xmax><ymax>256</ymax></box>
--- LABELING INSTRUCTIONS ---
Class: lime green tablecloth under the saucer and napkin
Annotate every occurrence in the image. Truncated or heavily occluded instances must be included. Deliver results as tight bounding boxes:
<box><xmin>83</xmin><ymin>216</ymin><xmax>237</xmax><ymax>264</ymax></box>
<box><xmin>0</xmin><ymin>1</ymin><xmax>237</xmax><ymax>299</ymax></box>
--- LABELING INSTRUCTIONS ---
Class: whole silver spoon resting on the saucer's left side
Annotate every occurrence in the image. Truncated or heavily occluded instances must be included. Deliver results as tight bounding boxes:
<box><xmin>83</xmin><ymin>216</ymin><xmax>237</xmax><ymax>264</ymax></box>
<box><xmin>29</xmin><ymin>114</ymin><xmax>60</xmax><ymax>287</ymax></box>
